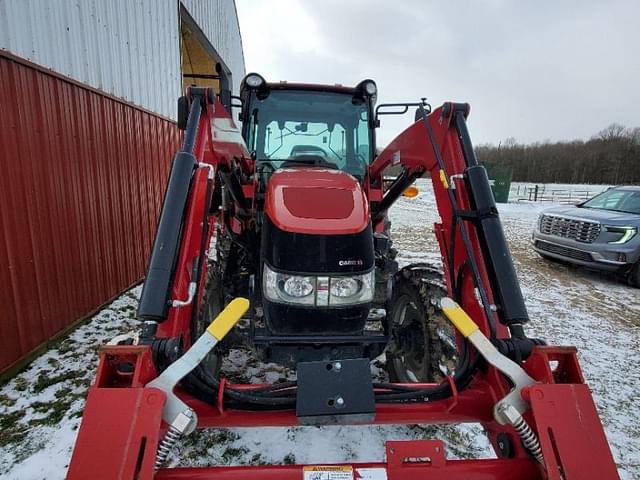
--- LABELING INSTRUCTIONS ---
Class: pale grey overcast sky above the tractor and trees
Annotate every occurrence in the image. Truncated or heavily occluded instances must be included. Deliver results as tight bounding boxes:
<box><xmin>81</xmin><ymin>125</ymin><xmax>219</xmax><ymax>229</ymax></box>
<box><xmin>236</xmin><ymin>0</ymin><xmax>640</xmax><ymax>146</ymax></box>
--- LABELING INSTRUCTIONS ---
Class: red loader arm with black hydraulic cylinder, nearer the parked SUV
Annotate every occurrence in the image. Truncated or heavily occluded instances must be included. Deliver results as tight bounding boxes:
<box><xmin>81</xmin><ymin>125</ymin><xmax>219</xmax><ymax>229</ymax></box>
<box><xmin>369</xmin><ymin>103</ymin><xmax>533</xmax><ymax>346</ymax></box>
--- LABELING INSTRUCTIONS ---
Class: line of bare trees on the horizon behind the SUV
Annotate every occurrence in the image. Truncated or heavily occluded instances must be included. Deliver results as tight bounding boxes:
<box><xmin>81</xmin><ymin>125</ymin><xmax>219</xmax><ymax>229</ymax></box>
<box><xmin>475</xmin><ymin>123</ymin><xmax>640</xmax><ymax>185</ymax></box>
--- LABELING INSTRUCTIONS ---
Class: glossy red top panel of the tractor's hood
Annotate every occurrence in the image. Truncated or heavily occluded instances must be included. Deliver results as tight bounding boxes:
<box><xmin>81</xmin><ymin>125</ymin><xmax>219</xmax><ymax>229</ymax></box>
<box><xmin>264</xmin><ymin>168</ymin><xmax>369</xmax><ymax>235</ymax></box>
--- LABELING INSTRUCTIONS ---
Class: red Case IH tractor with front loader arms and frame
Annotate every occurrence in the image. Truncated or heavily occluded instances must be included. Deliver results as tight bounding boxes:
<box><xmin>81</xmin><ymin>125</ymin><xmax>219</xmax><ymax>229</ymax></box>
<box><xmin>68</xmin><ymin>74</ymin><xmax>618</xmax><ymax>480</ymax></box>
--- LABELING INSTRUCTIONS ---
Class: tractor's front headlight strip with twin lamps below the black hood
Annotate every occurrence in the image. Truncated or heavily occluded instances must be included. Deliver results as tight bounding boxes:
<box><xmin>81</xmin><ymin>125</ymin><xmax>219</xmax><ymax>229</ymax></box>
<box><xmin>262</xmin><ymin>264</ymin><xmax>375</xmax><ymax>307</ymax></box>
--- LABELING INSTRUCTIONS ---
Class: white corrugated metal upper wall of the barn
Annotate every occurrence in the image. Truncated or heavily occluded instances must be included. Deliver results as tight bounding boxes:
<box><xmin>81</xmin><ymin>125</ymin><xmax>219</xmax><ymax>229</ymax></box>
<box><xmin>0</xmin><ymin>0</ymin><xmax>245</xmax><ymax>120</ymax></box>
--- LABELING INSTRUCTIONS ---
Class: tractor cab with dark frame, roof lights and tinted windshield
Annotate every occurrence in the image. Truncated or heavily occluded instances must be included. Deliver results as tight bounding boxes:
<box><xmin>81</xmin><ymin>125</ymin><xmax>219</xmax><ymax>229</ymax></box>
<box><xmin>241</xmin><ymin>73</ymin><xmax>377</xmax><ymax>189</ymax></box>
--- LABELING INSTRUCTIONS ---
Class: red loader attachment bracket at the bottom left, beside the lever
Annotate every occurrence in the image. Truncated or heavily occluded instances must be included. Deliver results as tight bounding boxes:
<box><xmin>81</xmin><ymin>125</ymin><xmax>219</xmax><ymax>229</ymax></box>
<box><xmin>67</xmin><ymin>346</ymin><xmax>166</xmax><ymax>480</ymax></box>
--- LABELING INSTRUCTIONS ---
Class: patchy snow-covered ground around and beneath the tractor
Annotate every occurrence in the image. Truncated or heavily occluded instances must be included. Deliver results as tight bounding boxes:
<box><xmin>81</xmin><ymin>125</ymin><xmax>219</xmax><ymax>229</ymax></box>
<box><xmin>0</xmin><ymin>183</ymin><xmax>640</xmax><ymax>480</ymax></box>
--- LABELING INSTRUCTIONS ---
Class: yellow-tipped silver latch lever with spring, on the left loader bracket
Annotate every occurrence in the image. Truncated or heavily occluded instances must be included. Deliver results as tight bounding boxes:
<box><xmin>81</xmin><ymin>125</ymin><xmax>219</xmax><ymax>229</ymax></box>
<box><xmin>145</xmin><ymin>298</ymin><xmax>249</xmax><ymax>470</ymax></box>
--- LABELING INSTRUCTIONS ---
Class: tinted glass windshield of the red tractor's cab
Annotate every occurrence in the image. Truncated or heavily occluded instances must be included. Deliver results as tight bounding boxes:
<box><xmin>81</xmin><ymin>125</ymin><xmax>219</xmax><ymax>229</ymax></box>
<box><xmin>247</xmin><ymin>90</ymin><xmax>371</xmax><ymax>179</ymax></box>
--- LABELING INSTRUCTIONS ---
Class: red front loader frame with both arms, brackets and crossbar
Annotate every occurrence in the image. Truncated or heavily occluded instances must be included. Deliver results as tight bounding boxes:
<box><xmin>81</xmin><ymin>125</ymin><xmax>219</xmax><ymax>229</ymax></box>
<box><xmin>67</xmin><ymin>88</ymin><xmax>619</xmax><ymax>480</ymax></box>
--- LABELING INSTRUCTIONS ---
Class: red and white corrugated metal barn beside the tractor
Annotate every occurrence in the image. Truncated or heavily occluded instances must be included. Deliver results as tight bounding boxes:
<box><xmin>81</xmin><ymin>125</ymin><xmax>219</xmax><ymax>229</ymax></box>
<box><xmin>0</xmin><ymin>0</ymin><xmax>245</xmax><ymax>376</ymax></box>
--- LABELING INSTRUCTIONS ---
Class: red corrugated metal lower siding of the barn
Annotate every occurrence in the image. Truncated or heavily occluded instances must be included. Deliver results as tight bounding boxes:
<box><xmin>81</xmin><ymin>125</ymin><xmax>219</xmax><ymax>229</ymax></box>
<box><xmin>0</xmin><ymin>52</ymin><xmax>179</xmax><ymax>372</ymax></box>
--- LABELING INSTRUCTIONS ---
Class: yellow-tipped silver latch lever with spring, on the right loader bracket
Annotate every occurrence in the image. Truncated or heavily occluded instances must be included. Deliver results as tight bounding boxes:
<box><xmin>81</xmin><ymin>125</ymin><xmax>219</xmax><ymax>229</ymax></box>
<box><xmin>440</xmin><ymin>297</ymin><xmax>544</xmax><ymax>465</ymax></box>
